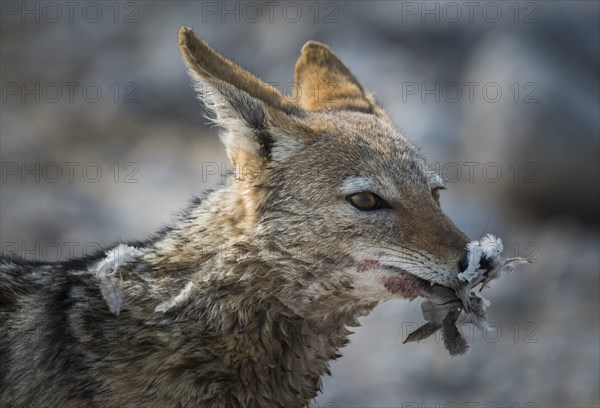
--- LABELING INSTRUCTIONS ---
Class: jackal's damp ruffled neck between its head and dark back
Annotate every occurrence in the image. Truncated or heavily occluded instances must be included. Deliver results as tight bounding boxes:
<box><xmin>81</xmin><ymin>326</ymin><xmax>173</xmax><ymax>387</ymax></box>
<box><xmin>128</xmin><ymin>190</ymin><xmax>376</xmax><ymax>406</ymax></box>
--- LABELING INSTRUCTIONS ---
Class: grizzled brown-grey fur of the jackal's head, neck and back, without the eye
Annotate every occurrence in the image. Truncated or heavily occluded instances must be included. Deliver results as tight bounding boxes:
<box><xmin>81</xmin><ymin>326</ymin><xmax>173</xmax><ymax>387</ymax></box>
<box><xmin>0</xmin><ymin>27</ymin><xmax>469</xmax><ymax>408</ymax></box>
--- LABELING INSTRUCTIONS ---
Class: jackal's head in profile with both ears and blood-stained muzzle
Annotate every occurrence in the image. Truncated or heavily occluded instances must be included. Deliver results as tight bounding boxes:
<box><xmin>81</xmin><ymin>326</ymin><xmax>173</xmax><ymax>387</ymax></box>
<box><xmin>179</xmin><ymin>27</ymin><xmax>478</xmax><ymax>301</ymax></box>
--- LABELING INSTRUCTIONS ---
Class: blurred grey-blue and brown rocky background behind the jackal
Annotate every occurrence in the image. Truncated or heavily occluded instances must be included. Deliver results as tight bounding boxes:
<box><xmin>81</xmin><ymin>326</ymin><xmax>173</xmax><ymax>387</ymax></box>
<box><xmin>0</xmin><ymin>1</ymin><xmax>600</xmax><ymax>408</ymax></box>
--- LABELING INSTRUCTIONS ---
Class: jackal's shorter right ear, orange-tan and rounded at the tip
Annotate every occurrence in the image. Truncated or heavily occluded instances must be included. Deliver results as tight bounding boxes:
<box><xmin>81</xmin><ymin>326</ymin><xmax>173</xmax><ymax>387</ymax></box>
<box><xmin>294</xmin><ymin>41</ymin><xmax>383</xmax><ymax>114</ymax></box>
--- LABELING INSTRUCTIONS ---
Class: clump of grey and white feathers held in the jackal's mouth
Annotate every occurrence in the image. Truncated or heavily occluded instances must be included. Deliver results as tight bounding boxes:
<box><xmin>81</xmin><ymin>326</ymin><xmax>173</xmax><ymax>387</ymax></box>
<box><xmin>398</xmin><ymin>234</ymin><xmax>529</xmax><ymax>356</ymax></box>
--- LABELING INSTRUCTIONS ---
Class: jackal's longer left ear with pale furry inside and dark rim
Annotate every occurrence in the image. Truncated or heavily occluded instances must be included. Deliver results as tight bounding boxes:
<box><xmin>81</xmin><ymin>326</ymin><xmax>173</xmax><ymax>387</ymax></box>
<box><xmin>179</xmin><ymin>27</ymin><xmax>300</xmax><ymax>166</ymax></box>
